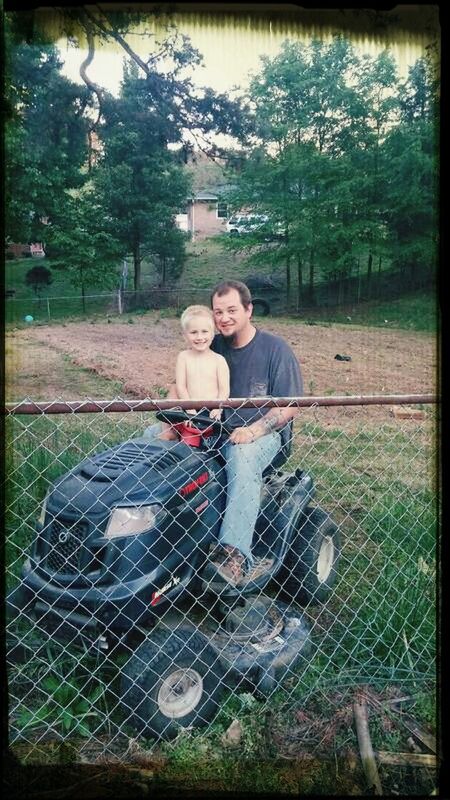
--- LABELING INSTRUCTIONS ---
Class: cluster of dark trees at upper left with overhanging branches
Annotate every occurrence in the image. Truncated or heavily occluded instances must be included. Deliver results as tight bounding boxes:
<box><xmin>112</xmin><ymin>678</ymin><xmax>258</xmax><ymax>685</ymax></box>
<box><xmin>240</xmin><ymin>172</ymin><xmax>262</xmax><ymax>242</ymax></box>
<box><xmin>7</xmin><ymin>6</ymin><xmax>250</xmax><ymax>289</ymax></box>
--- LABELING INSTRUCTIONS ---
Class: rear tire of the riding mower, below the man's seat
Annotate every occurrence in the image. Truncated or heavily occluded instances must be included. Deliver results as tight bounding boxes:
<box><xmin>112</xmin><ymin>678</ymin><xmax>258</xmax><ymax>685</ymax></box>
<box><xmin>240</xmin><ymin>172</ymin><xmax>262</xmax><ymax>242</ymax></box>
<box><xmin>277</xmin><ymin>507</ymin><xmax>340</xmax><ymax>604</ymax></box>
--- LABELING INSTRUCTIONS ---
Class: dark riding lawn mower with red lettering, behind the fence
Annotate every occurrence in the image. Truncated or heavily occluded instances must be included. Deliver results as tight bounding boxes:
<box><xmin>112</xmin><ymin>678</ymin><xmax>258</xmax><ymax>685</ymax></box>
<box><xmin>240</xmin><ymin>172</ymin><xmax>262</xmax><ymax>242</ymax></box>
<box><xmin>8</xmin><ymin>410</ymin><xmax>340</xmax><ymax>738</ymax></box>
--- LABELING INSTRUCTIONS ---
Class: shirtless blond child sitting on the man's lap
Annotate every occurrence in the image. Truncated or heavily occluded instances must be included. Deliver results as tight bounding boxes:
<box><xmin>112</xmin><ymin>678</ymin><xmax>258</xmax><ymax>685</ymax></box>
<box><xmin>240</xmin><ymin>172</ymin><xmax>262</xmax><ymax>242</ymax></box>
<box><xmin>175</xmin><ymin>306</ymin><xmax>230</xmax><ymax>419</ymax></box>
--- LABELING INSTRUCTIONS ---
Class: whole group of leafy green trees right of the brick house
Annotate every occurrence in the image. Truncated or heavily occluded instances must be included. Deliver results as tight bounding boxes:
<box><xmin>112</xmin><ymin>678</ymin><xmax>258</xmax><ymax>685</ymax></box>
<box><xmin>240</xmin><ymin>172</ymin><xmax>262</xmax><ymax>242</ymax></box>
<box><xmin>225</xmin><ymin>36</ymin><xmax>437</xmax><ymax>307</ymax></box>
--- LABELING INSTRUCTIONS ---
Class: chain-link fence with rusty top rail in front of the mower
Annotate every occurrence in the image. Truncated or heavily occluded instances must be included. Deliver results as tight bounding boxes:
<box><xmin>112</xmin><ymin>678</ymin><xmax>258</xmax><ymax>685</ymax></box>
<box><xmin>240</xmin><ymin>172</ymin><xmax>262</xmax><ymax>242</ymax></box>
<box><xmin>5</xmin><ymin>396</ymin><xmax>438</xmax><ymax>761</ymax></box>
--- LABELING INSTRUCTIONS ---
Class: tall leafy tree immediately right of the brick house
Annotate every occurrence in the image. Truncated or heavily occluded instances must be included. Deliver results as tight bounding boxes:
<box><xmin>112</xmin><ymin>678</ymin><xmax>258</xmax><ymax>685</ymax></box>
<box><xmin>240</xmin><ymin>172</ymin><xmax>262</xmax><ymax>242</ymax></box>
<box><xmin>223</xmin><ymin>37</ymin><xmax>361</xmax><ymax>304</ymax></box>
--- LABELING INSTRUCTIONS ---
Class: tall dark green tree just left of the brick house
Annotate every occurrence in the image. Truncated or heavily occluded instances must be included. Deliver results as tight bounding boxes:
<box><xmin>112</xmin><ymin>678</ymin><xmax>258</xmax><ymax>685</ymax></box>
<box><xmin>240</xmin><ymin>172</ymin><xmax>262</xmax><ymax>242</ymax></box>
<box><xmin>91</xmin><ymin>59</ymin><xmax>189</xmax><ymax>291</ymax></box>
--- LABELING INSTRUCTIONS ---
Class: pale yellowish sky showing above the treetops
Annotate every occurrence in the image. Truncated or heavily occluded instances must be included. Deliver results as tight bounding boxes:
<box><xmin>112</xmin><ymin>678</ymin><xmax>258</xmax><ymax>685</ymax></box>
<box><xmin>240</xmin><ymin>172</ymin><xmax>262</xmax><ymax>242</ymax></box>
<box><xmin>58</xmin><ymin>9</ymin><xmax>436</xmax><ymax>94</ymax></box>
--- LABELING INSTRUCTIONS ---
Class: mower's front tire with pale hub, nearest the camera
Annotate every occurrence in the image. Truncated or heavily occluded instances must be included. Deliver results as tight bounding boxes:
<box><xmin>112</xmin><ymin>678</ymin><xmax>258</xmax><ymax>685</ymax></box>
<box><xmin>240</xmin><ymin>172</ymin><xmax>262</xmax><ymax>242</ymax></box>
<box><xmin>121</xmin><ymin>629</ymin><xmax>226</xmax><ymax>739</ymax></box>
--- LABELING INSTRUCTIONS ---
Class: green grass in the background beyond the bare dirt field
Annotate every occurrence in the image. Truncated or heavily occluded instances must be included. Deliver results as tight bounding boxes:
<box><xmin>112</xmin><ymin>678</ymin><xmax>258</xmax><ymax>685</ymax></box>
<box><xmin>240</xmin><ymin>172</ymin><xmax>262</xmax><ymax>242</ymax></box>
<box><xmin>5</xmin><ymin>242</ymin><xmax>438</xmax><ymax>332</ymax></box>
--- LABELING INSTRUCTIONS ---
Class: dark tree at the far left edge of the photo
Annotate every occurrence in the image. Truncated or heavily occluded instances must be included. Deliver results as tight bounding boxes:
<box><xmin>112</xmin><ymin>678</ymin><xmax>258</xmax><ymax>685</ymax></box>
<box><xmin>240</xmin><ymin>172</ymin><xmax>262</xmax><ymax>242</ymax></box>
<box><xmin>5</xmin><ymin>18</ymin><xmax>89</xmax><ymax>241</ymax></box>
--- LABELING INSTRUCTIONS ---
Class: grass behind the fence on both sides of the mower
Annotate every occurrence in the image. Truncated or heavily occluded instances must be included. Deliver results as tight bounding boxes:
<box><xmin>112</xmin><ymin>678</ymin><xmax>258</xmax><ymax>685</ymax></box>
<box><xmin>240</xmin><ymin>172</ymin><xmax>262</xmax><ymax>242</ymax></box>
<box><xmin>6</xmin><ymin>414</ymin><xmax>437</xmax><ymax>692</ymax></box>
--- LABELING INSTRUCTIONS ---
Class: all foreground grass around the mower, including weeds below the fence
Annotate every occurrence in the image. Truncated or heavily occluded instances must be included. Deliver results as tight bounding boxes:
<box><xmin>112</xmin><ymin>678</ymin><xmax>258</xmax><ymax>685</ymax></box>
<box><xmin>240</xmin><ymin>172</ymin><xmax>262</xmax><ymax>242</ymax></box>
<box><xmin>6</xmin><ymin>306</ymin><xmax>437</xmax><ymax>794</ymax></box>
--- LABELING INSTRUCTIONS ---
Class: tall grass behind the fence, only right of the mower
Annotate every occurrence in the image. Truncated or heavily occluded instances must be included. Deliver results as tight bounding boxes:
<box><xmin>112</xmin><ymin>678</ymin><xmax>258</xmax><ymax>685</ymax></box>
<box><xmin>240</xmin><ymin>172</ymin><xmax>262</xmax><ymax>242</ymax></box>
<box><xmin>289</xmin><ymin>422</ymin><xmax>438</xmax><ymax>680</ymax></box>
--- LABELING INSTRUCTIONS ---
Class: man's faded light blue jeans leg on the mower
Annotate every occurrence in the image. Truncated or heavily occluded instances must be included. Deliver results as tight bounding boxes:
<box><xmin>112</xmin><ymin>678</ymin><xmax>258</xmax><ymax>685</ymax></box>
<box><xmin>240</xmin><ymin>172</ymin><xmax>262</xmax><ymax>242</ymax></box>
<box><xmin>219</xmin><ymin>431</ymin><xmax>281</xmax><ymax>567</ymax></box>
